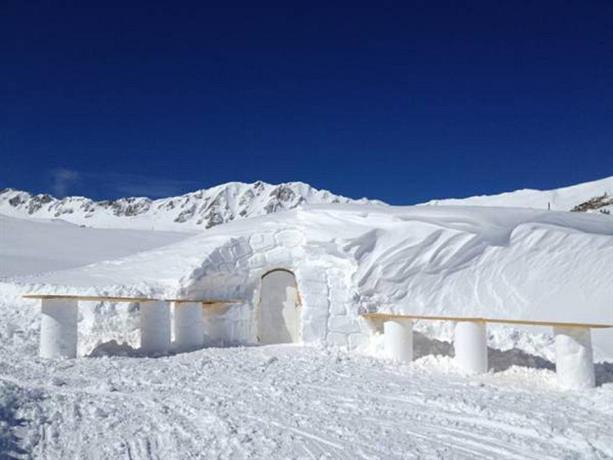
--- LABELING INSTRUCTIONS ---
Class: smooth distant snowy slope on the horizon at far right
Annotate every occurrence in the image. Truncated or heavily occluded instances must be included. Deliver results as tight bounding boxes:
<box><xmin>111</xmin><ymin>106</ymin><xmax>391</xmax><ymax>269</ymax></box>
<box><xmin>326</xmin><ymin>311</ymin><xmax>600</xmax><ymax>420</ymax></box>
<box><xmin>424</xmin><ymin>176</ymin><xmax>613</xmax><ymax>211</ymax></box>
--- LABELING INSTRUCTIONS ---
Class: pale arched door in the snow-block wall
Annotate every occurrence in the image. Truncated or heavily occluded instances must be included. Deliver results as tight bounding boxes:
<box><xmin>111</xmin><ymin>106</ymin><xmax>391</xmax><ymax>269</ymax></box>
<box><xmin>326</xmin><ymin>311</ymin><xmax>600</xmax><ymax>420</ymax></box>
<box><xmin>258</xmin><ymin>269</ymin><xmax>302</xmax><ymax>344</ymax></box>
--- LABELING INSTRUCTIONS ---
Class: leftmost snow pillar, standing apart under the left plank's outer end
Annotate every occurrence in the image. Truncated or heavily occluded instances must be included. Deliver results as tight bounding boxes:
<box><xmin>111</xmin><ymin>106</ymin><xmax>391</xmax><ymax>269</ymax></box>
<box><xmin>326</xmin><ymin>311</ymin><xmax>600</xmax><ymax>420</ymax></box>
<box><xmin>39</xmin><ymin>298</ymin><xmax>79</xmax><ymax>358</ymax></box>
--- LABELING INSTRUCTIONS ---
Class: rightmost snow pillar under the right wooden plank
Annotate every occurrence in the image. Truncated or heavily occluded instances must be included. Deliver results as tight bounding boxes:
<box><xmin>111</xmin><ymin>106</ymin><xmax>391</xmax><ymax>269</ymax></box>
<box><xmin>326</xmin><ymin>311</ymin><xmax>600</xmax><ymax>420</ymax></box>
<box><xmin>553</xmin><ymin>326</ymin><xmax>596</xmax><ymax>389</ymax></box>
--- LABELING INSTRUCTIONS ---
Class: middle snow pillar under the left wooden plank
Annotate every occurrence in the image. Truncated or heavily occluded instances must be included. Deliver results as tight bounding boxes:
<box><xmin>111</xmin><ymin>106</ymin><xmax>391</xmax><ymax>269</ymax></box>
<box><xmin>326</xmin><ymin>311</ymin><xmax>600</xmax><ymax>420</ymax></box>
<box><xmin>140</xmin><ymin>300</ymin><xmax>170</xmax><ymax>355</ymax></box>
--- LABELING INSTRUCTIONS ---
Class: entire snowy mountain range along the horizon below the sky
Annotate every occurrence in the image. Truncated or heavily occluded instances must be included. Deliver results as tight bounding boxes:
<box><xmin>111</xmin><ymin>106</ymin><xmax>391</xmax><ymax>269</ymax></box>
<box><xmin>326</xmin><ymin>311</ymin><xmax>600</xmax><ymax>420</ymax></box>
<box><xmin>0</xmin><ymin>176</ymin><xmax>613</xmax><ymax>231</ymax></box>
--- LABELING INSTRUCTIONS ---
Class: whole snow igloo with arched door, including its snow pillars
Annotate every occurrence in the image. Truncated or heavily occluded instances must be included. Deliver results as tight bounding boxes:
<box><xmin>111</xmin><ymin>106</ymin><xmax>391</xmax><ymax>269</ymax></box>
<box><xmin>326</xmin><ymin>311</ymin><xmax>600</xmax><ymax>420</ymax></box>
<box><xmin>21</xmin><ymin>205</ymin><xmax>613</xmax><ymax>387</ymax></box>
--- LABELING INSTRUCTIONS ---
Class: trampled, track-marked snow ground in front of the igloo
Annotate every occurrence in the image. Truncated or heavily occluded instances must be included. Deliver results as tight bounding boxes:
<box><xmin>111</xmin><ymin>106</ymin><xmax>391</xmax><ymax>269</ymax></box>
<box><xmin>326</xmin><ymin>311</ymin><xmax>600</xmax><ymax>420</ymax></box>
<box><xmin>0</xmin><ymin>345</ymin><xmax>613</xmax><ymax>460</ymax></box>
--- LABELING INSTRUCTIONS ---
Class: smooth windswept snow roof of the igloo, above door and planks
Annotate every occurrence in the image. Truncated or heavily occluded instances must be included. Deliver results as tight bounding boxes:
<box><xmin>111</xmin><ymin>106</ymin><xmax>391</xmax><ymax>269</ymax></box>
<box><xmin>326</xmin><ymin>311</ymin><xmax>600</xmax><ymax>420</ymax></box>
<box><xmin>21</xmin><ymin>205</ymin><xmax>613</xmax><ymax>324</ymax></box>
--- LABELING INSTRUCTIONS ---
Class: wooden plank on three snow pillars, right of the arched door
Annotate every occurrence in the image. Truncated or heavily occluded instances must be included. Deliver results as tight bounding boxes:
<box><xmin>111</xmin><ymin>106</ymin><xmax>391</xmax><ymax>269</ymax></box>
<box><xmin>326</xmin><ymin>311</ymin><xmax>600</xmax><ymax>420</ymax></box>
<box><xmin>362</xmin><ymin>313</ymin><xmax>613</xmax><ymax>389</ymax></box>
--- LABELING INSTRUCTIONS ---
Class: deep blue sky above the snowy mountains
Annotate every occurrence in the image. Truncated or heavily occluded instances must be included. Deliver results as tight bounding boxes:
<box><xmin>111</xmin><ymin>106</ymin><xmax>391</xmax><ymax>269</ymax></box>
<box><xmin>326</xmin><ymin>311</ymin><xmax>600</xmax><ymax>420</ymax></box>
<box><xmin>0</xmin><ymin>0</ymin><xmax>613</xmax><ymax>204</ymax></box>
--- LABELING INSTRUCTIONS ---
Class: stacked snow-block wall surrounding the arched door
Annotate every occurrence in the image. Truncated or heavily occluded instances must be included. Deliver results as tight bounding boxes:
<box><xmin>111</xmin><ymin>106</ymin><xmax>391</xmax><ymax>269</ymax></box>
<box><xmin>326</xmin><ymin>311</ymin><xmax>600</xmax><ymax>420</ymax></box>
<box><xmin>177</xmin><ymin>229</ymin><xmax>370</xmax><ymax>348</ymax></box>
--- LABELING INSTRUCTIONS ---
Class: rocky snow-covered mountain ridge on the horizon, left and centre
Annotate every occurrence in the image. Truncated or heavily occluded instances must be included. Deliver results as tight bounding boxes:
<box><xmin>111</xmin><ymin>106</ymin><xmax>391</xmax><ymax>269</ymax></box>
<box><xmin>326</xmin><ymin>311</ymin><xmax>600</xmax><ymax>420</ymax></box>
<box><xmin>0</xmin><ymin>181</ymin><xmax>383</xmax><ymax>231</ymax></box>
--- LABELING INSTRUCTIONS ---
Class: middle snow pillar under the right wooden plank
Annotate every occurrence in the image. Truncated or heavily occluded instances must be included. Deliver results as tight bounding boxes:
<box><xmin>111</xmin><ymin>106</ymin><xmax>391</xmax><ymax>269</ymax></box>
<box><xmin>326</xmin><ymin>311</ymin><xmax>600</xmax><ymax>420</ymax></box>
<box><xmin>453</xmin><ymin>321</ymin><xmax>487</xmax><ymax>374</ymax></box>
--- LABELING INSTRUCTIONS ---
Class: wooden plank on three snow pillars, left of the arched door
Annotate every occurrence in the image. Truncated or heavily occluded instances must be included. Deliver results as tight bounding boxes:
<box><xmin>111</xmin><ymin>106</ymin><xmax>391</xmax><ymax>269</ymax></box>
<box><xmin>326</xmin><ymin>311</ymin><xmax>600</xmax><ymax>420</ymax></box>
<box><xmin>23</xmin><ymin>294</ymin><xmax>239</xmax><ymax>358</ymax></box>
